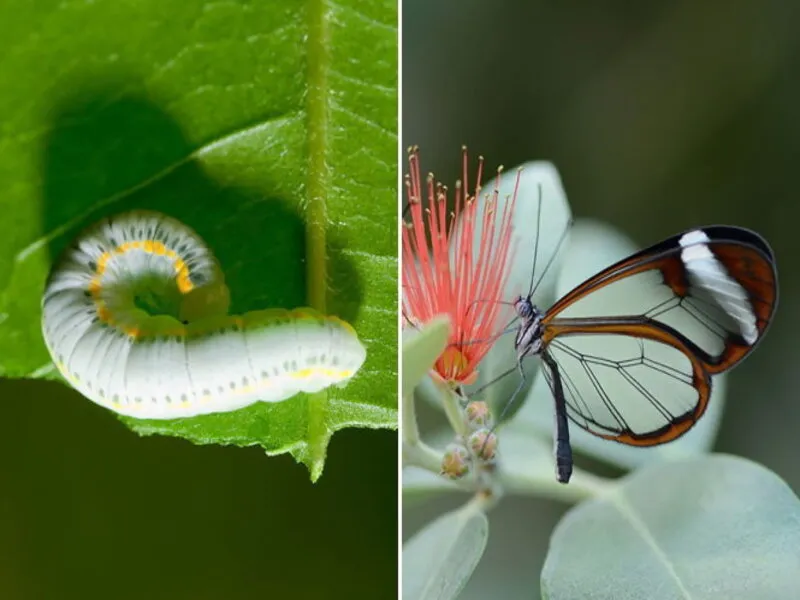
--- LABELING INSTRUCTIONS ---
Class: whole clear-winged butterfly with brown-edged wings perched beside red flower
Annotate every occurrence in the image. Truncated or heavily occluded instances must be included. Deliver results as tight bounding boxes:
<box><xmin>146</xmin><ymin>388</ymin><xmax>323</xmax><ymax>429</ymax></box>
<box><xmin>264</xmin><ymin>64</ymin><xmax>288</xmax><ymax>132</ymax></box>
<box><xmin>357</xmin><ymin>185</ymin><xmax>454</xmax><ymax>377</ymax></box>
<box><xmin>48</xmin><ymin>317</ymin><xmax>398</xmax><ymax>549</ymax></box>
<box><xmin>501</xmin><ymin>219</ymin><xmax>778</xmax><ymax>483</ymax></box>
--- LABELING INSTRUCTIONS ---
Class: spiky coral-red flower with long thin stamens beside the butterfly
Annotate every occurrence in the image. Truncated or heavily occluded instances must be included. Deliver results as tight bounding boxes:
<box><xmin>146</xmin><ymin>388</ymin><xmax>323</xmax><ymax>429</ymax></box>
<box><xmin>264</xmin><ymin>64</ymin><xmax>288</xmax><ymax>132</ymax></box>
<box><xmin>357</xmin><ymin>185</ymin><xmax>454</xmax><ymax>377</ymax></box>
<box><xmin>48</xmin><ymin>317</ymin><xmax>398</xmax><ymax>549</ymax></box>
<box><xmin>403</xmin><ymin>148</ymin><xmax>519</xmax><ymax>385</ymax></box>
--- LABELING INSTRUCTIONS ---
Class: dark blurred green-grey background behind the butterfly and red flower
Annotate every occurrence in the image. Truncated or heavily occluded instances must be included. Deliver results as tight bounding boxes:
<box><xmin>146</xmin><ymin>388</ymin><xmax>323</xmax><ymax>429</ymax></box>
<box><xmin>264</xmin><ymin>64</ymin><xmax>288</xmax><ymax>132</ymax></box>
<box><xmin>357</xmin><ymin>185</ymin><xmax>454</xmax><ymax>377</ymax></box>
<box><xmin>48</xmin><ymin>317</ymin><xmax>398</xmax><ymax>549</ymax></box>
<box><xmin>402</xmin><ymin>0</ymin><xmax>800</xmax><ymax>599</ymax></box>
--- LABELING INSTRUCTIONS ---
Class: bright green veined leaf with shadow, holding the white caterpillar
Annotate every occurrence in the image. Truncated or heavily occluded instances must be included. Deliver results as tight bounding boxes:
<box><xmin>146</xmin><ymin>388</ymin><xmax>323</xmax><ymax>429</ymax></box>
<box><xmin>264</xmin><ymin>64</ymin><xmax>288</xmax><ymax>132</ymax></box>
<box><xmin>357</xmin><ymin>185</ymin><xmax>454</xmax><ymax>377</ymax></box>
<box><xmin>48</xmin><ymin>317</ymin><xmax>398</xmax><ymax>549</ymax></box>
<box><xmin>0</xmin><ymin>0</ymin><xmax>397</xmax><ymax>479</ymax></box>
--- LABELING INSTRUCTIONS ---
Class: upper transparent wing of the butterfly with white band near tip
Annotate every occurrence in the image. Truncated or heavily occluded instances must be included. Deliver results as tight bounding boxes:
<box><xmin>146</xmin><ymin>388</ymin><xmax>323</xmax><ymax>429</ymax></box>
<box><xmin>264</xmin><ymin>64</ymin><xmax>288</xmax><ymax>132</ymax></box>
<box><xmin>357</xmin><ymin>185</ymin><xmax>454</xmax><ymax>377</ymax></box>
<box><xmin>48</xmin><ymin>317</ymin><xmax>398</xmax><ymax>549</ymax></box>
<box><xmin>546</xmin><ymin>227</ymin><xmax>777</xmax><ymax>373</ymax></box>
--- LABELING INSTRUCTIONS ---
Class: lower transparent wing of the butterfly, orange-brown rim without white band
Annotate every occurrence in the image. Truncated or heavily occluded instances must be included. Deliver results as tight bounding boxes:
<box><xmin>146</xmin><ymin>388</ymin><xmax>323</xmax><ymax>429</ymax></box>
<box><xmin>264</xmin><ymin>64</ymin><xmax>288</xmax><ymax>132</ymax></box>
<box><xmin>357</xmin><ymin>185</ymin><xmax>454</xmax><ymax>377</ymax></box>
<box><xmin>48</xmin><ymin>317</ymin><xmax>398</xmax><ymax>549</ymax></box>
<box><xmin>544</xmin><ymin>325</ymin><xmax>711</xmax><ymax>446</ymax></box>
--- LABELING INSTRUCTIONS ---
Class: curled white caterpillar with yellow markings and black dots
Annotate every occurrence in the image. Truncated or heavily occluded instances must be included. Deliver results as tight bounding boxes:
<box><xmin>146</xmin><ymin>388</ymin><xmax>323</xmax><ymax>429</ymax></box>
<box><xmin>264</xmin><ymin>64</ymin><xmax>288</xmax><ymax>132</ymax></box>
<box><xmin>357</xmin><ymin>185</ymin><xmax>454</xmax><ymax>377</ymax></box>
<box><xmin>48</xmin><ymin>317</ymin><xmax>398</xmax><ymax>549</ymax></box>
<box><xmin>42</xmin><ymin>211</ymin><xmax>366</xmax><ymax>419</ymax></box>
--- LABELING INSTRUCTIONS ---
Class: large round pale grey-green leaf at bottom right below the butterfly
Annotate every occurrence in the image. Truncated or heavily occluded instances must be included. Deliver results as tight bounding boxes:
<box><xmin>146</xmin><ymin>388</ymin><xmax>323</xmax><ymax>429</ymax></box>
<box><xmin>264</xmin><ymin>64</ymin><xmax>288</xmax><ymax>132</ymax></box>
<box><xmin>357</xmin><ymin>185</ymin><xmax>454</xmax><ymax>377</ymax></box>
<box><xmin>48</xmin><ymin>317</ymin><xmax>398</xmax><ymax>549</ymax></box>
<box><xmin>541</xmin><ymin>455</ymin><xmax>800</xmax><ymax>600</ymax></box>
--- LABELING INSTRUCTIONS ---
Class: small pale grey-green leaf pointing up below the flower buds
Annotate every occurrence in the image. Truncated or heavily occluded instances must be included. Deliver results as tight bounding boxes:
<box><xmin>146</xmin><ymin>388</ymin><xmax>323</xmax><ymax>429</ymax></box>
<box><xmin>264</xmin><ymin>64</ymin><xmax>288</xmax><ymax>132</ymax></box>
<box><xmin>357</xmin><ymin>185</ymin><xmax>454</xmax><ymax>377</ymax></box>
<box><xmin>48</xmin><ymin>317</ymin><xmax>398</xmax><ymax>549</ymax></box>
<box><xmin>403</xmin><ymin>504</ymin><xmax>489</xmax><ymax>600</ymax></box>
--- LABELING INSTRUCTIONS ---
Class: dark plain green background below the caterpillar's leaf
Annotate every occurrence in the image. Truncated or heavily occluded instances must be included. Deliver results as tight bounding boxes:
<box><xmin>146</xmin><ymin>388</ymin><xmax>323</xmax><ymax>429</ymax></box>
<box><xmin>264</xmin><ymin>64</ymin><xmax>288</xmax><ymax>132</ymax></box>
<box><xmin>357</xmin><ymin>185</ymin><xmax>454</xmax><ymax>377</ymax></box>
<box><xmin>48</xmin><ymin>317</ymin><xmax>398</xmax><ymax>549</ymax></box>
<box><xmin>0</xmin><ymin>380</ymin><xmax>397</xmax><ymax>600</ymax></box>
